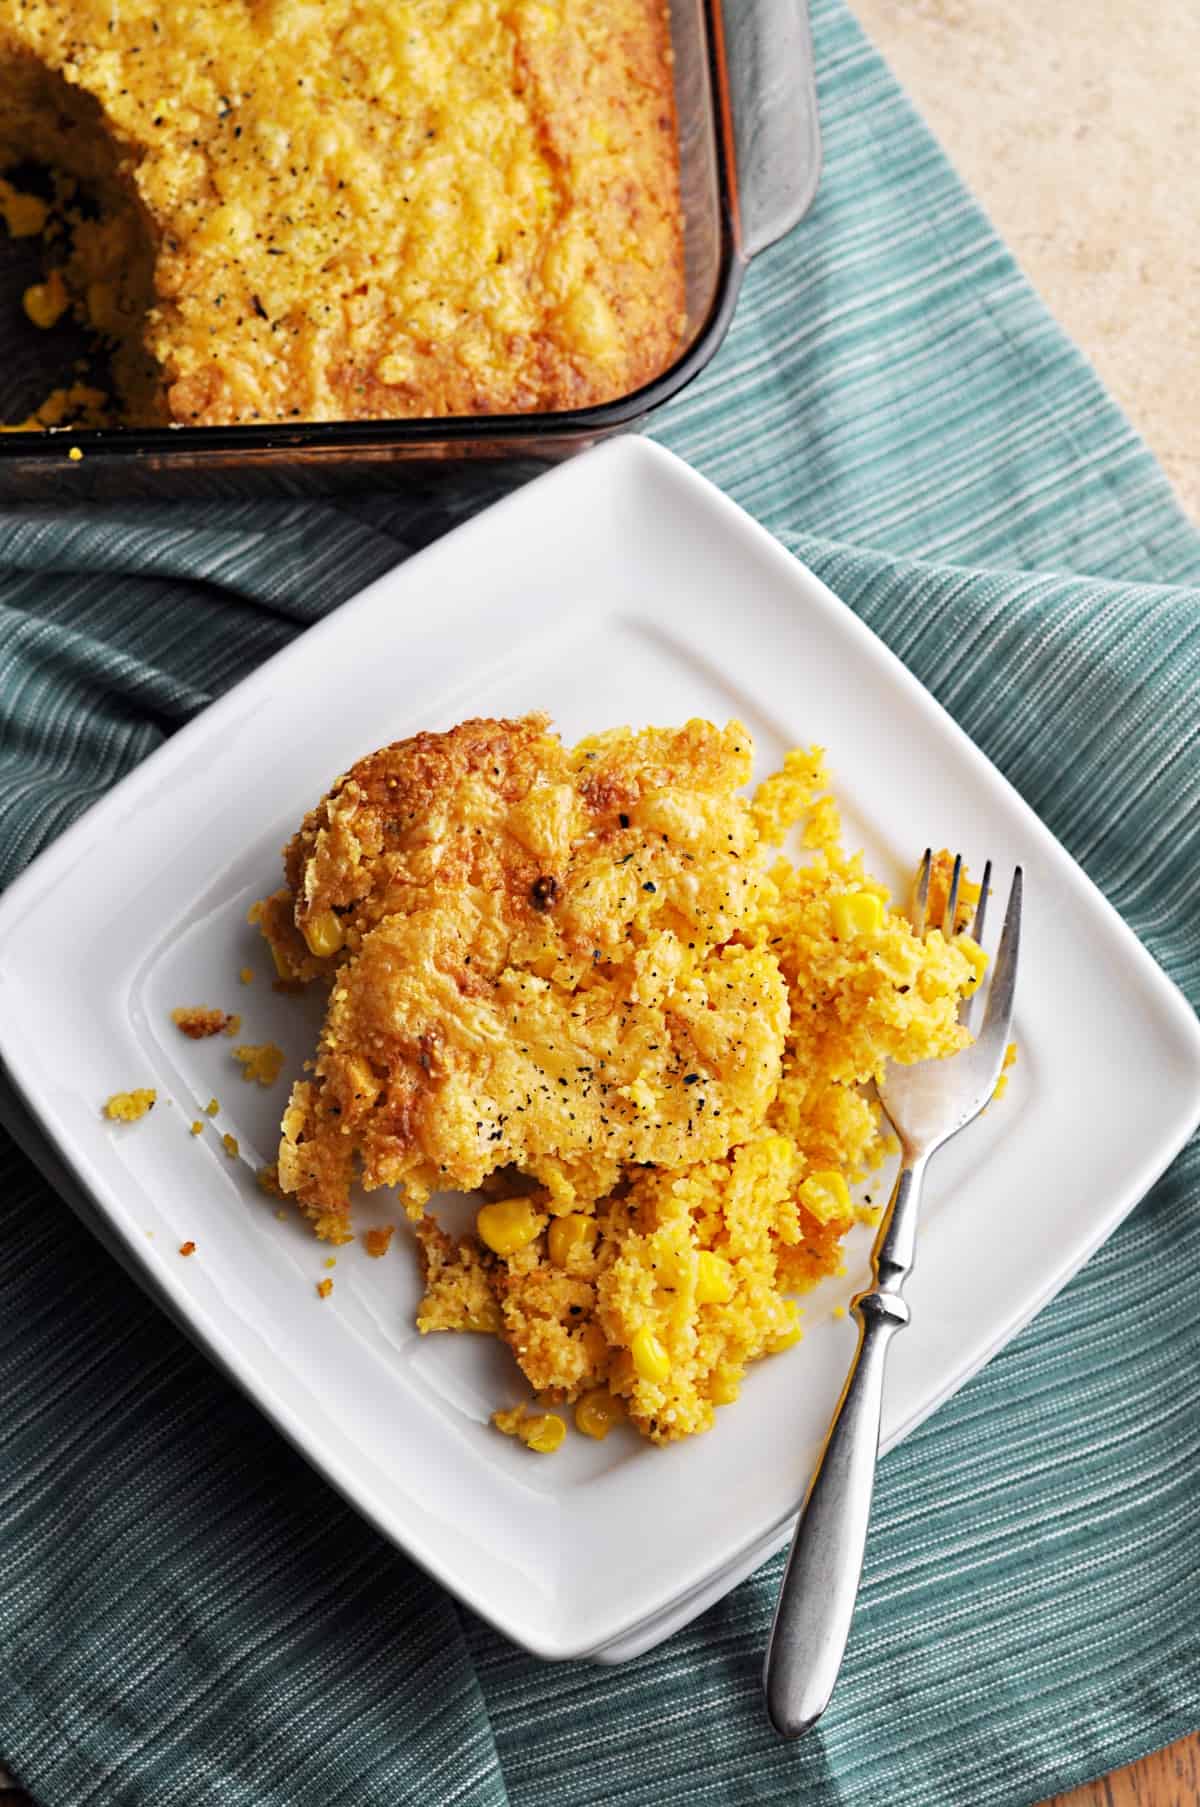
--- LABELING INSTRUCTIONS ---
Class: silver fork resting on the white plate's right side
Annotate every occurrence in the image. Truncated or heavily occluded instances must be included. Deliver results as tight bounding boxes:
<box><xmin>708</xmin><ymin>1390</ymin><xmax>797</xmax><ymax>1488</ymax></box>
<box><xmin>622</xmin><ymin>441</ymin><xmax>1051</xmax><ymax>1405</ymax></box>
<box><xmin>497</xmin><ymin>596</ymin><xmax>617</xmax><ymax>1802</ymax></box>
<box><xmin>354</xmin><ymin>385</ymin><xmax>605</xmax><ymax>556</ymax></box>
<box><xmin>763</xmin><ymin>851</ymin><xmax>1021</xmax><ymax>1738</ymax></box>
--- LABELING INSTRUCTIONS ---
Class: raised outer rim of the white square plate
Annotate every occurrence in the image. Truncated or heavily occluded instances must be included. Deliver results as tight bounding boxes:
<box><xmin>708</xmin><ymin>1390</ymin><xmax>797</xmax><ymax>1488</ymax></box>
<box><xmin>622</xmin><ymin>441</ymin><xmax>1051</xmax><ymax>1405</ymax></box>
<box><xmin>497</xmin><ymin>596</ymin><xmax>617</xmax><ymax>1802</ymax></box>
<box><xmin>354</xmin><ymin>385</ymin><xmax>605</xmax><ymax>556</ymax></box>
<box><xmin>0</xmin><ymin>437</ymin><xmax>1200</xmax><ymax>1659</ymax></box>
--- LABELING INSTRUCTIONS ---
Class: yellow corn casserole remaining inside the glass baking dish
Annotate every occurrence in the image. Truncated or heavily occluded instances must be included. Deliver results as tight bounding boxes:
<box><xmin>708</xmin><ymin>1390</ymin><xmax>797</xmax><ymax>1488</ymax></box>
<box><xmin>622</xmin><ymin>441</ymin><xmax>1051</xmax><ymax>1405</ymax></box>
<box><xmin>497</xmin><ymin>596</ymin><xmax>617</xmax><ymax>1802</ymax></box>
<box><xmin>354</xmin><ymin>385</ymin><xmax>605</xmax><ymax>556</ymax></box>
<box><xmin>0</xmin><ymin>0</ymin><xmax>685</xmax><ymax>426</ymax></box>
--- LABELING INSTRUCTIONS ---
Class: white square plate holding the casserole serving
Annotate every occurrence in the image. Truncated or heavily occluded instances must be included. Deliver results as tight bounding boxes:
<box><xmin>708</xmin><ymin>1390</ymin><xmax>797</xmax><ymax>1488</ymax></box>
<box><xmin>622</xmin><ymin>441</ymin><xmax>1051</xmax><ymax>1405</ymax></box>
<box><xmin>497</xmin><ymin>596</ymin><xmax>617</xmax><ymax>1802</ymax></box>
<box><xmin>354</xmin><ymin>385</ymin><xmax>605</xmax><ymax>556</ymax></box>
<box><xmin>0</xmin><ymin>439</ymin><xmax>1200</xmax><ymax>1659</ymax></box>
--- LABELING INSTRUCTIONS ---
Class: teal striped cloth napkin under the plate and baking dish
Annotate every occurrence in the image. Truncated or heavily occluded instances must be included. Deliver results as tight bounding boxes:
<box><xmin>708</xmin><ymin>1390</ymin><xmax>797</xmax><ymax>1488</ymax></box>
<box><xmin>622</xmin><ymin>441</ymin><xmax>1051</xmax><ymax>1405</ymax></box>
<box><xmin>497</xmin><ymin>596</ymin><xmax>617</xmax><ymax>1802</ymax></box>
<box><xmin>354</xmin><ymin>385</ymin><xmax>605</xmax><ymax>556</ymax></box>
<box><xmin>0</xmin><ymin>0</ymin><xmax>1200</xmax><ymax>1807</ymax></box>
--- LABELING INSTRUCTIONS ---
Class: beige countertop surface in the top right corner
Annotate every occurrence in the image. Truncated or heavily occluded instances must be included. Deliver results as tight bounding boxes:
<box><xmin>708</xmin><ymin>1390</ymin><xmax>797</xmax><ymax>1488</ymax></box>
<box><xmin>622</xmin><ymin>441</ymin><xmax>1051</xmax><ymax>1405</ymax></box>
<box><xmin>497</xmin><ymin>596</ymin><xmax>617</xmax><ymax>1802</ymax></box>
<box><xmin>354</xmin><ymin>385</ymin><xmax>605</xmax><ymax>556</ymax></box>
<box><xmin>849</xmin><ymin>0</ymin><xmax>1200</xmax><ymax>522</ymax></box>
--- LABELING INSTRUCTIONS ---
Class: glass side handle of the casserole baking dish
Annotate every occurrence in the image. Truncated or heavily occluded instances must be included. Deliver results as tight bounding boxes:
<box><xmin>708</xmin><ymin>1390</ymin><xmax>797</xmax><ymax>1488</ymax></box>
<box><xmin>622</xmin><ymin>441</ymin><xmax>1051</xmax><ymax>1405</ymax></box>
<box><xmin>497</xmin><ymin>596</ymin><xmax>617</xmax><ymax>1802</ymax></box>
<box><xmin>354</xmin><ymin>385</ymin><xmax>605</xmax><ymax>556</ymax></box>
<box><xmin>721</xmin><ymin>0</ymin><xmax>820</xmax><ymax>260</ymax></box>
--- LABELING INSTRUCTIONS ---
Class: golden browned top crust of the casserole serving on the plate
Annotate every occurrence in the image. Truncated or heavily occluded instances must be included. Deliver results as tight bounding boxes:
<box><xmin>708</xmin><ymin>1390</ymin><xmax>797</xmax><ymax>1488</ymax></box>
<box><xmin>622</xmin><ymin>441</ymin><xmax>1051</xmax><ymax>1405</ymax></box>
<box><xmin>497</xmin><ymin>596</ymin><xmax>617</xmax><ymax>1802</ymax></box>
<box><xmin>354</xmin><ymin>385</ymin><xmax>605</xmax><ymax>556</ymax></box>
<box><xmin>260</xmin><ymin>716</ymin><xmax>786</xmax><ymax>1227</ymax></box>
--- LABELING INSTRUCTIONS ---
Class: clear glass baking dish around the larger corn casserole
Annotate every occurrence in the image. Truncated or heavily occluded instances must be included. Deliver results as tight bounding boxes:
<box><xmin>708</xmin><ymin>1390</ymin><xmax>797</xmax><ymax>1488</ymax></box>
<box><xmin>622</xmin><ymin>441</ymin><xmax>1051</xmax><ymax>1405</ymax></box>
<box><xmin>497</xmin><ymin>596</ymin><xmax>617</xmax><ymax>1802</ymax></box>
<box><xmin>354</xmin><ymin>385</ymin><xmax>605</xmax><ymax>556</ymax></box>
<box><xmin>0</xmin><ymin>0</ymin><xmax>820</xmax><ymax>501</ymax></box>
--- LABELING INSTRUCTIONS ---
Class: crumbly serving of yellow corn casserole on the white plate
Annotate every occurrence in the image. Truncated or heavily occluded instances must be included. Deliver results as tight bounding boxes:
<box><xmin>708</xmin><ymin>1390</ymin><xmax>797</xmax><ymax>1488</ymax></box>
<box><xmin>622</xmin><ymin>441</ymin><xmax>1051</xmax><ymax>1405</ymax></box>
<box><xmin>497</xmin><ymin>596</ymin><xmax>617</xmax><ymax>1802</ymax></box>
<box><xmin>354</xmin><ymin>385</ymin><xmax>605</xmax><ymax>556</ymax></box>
<box><xmin>251</xmin><ymin>716</ymin><xmax>983</xmax><ymax>1451</ymax></box>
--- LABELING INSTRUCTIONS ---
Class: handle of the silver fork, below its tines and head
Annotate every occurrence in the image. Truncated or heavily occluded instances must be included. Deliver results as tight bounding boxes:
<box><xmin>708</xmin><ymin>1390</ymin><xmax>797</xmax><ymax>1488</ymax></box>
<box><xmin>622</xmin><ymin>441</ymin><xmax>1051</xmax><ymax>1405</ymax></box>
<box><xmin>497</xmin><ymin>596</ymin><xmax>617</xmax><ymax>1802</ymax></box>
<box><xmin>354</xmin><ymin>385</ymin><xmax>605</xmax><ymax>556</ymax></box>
<box><xmin>763</xmin><ymin>1158</ymin><xmax>925</xmax><ymax>1738</ymax></box>
